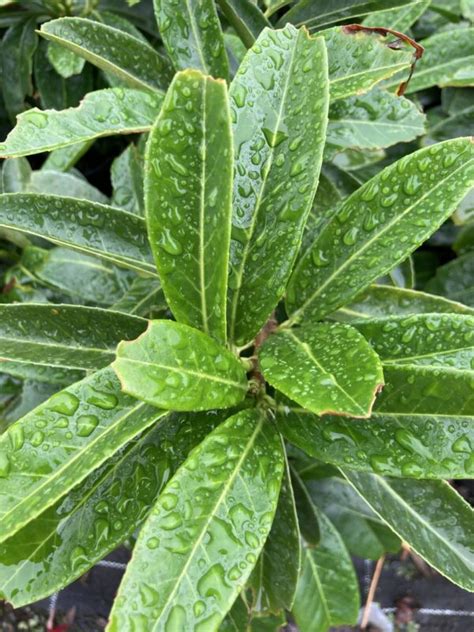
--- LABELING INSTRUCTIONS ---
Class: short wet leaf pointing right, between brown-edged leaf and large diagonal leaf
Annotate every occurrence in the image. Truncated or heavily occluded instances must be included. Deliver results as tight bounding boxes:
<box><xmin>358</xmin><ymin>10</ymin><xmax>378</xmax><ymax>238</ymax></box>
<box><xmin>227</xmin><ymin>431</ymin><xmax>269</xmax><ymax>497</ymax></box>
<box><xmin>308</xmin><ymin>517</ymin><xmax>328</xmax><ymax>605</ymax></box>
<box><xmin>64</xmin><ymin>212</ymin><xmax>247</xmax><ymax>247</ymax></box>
<box><xmin>325</xmin><ymin>88</ymin><xmax>425</xmax><ymax>157</ymax></box>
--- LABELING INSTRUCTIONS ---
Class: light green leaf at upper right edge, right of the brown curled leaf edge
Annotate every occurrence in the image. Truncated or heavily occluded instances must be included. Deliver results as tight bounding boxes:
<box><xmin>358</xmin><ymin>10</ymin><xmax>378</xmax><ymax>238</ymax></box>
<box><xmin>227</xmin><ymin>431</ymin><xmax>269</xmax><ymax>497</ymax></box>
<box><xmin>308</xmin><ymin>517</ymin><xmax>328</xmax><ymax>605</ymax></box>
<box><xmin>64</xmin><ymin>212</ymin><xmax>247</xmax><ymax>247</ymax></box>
<box><xmin>387</xmin><ymin>28</ymin><xmax>474</xmax><ymax>94</ymax></box>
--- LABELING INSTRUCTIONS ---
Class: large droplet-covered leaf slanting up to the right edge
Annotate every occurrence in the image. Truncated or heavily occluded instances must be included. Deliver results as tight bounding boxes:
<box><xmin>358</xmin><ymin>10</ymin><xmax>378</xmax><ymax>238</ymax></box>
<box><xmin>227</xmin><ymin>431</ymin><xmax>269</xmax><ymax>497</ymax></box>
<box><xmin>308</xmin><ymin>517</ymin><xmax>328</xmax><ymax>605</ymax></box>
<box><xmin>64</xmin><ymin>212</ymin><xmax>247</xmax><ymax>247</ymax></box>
<box><xmin>286</xmin><ymin>138</ymin><xmax>474</xmax><ymax>321</ymax></box>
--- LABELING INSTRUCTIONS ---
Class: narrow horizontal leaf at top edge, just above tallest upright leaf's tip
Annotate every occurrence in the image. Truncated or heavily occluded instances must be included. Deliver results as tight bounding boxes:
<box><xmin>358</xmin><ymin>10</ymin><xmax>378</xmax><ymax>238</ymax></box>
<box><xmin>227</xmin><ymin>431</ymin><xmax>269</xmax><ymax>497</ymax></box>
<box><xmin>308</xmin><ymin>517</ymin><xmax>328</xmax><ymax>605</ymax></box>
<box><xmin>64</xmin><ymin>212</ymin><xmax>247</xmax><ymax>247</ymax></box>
<box><xmin>278</xmin><ymin>0</ymin><xmax>410</xmax><ymax>30</ymax></box>
